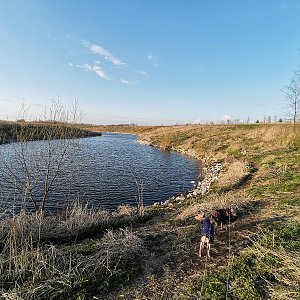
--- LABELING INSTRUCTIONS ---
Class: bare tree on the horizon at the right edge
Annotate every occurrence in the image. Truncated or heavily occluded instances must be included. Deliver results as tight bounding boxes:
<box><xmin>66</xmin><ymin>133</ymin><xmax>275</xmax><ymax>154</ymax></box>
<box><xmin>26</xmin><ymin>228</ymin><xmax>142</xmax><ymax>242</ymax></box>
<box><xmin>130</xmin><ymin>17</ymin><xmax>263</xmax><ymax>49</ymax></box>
<box><xmin>281</xmin><ymin>69</ymin><xmax>300</xmax><ymax>131</ymax></box>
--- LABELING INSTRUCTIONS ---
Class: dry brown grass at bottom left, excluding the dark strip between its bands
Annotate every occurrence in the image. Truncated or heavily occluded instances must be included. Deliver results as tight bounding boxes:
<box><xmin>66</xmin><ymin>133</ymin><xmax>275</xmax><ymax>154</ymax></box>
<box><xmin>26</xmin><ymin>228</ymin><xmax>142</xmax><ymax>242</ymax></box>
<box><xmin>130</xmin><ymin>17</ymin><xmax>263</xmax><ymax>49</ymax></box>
<box><xmin>0</xmin><ymin>202</ymin><xmax>145</xmax><ymax>299</ymax></box>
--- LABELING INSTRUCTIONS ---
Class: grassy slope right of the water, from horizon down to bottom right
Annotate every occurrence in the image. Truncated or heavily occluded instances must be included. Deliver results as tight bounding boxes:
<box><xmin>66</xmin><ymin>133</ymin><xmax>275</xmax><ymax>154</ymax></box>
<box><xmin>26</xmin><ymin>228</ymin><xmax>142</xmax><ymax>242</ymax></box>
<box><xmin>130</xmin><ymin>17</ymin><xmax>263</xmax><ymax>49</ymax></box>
<box><xmin>85</xmin><ymin>124</ymin><xmax>300</xmax><ymax>299</ymax></box>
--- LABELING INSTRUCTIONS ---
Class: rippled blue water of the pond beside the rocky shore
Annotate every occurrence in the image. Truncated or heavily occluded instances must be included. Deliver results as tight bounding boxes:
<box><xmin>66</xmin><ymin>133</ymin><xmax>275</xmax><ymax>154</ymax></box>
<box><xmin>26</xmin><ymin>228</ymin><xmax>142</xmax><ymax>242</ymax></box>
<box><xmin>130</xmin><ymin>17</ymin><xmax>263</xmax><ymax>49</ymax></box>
<box><xmin>0</xmin><ymin>133</ymin><xmax>199</xmax><ymax>210</ymax></box>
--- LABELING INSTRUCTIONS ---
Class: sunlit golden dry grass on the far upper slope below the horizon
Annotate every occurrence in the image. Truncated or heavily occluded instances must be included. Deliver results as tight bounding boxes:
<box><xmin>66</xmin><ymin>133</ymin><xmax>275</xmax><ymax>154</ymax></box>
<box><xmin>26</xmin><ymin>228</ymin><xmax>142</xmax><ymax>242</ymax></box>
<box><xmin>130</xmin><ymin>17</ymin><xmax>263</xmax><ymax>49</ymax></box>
<box><xmin>114</xmin><ymin>124</ymin><xmax>300</xmax><ymax>160</ymax></box>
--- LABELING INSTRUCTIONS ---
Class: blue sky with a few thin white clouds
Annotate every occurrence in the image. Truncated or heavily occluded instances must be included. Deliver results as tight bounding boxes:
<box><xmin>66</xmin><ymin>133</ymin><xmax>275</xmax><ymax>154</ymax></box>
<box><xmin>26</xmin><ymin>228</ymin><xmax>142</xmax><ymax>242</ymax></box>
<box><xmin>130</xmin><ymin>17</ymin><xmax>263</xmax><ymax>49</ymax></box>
<box><xmin>0</xmin><ymin>0</ymin><xmax>300</xmax><ymax>125</ymax></box>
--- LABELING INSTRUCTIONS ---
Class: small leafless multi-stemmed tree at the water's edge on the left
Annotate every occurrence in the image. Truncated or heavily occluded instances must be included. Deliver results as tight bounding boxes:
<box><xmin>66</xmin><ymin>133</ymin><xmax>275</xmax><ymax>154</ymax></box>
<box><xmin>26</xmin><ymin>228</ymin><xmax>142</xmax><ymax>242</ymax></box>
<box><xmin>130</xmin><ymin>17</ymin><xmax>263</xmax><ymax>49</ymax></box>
<box><xmin>0</xmin><ymin>99</ymin><xmax>80</xmax><ymax>212</ymax></box>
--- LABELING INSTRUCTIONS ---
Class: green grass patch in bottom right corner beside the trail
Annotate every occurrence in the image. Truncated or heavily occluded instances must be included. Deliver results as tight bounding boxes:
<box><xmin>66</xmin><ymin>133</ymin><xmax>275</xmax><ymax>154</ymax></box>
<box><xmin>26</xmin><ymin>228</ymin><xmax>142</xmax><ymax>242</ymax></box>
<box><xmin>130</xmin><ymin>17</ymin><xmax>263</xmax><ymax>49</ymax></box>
<box><xmin>183</xmin><ymin>224</ymin><xmax>300</xmax><ymax>300</ymax></box>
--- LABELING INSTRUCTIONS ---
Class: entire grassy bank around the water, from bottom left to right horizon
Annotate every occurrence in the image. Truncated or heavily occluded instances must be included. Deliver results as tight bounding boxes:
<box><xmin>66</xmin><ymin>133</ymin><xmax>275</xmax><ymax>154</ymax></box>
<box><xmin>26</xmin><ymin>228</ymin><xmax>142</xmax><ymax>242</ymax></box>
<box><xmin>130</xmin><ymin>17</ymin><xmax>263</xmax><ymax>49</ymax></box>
<box><xmin>0</xmin><ymin>124</ymin><xmax>300</xmax><ymax>299</ymax></box>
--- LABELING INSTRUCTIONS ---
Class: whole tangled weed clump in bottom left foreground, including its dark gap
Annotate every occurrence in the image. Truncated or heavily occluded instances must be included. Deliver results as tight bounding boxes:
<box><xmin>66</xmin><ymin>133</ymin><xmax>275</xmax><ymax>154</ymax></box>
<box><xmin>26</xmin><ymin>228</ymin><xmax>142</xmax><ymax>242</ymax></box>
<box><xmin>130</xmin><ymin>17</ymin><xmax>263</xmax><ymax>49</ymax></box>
<box><xmin>0</xmin><ymin>204</ymin><xmax>145</xmax><ymax>299</ymax></box>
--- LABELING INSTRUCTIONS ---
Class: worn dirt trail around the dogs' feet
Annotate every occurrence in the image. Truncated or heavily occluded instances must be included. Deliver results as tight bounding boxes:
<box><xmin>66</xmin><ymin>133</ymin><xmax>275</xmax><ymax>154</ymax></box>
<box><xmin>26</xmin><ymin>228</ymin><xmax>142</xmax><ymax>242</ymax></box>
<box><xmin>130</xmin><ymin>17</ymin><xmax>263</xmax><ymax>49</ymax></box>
<box><xmin>135</xmin><ymin>202</ymin><xmax>280</xmax><ymax>282</ymax></box>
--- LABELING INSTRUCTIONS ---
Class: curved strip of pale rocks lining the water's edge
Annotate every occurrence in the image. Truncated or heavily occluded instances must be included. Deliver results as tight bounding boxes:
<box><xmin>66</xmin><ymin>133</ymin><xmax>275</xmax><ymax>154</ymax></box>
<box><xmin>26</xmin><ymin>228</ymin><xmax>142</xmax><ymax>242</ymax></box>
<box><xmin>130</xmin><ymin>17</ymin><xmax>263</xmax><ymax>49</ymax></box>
<box><xmin>137</xmin><ymin>139</ymin><xmax>222</xmax><ymax>206</ymax></box>
